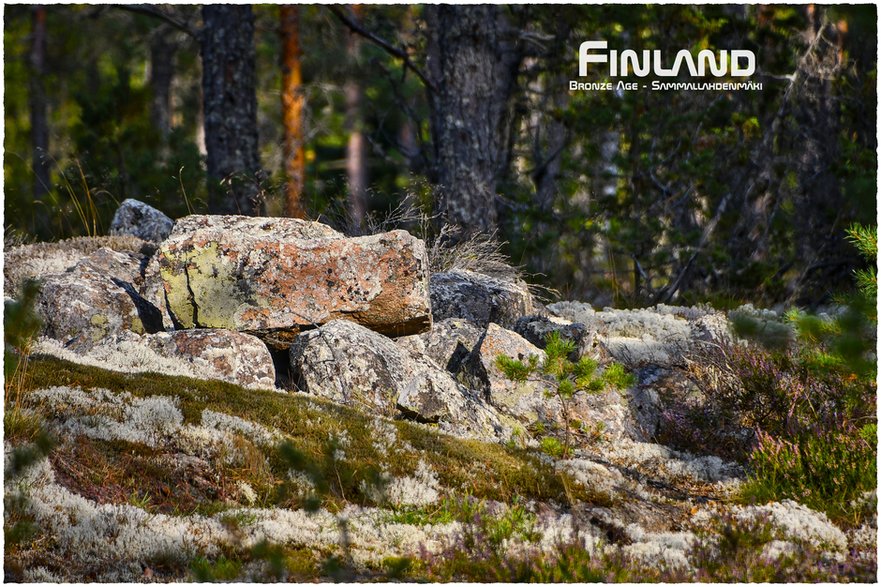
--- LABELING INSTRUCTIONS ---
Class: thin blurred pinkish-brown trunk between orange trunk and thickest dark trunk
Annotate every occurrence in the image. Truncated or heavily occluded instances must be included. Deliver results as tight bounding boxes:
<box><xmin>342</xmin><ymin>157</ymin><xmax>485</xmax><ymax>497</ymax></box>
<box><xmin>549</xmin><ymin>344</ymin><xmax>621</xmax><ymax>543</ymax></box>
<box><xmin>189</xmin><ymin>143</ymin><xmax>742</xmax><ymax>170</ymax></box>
<box><xmin>343</xmin><ymin>5</ymin><xmax>367</xmax><ymax>228</ymax></box>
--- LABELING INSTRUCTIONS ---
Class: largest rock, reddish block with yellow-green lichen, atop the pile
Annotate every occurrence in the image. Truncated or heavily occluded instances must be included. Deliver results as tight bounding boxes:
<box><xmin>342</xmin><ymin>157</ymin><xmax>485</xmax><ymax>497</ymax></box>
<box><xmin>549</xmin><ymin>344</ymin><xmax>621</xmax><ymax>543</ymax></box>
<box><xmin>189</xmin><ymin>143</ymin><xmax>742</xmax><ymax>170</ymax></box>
<box><xmin>157</xmin><ymin>216</ymin><xmax>431</xmax><ymax>347</ymax></box>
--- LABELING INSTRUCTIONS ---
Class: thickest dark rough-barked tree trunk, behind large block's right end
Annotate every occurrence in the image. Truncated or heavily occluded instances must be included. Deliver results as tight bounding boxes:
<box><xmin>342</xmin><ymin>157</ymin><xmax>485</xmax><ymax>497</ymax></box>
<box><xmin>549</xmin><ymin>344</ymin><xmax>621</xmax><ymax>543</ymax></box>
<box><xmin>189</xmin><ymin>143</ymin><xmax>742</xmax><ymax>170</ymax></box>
<box><xmin>425</xmin><ymin>5</ymin><xmax>521</xmax><ymax>232</ymax></box>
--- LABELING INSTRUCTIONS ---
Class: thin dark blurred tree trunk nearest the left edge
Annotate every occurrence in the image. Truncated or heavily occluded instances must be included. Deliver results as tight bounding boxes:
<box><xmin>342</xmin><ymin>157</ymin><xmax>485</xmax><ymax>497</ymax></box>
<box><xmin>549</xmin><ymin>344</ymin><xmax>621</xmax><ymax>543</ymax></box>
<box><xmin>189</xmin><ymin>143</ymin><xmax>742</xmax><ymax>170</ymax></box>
<box><xmin>29</xmin><ymin>6</ymin><xmax>51</xmax><ymax>236</ymax></box>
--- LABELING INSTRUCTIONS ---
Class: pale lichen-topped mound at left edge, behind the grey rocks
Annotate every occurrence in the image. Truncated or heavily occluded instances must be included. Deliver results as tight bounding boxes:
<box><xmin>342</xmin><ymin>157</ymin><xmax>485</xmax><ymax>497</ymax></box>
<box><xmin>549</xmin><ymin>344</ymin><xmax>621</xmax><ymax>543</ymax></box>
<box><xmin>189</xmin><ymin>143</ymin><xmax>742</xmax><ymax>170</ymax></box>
<box><xmin>3</xmin><ymin>236</ymin><xmax>155</xmax><ymax>298</ymax></box>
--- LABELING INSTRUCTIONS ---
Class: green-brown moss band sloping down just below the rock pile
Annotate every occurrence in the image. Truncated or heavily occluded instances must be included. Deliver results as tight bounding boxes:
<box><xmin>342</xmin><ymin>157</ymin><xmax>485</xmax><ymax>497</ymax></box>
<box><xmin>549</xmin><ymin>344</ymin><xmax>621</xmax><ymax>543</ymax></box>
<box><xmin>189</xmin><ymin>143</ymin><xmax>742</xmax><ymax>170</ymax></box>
<box><xmin>27</xmin><ymin>357</ymin><xmax>596</xmax><ymax>508</ymax></box>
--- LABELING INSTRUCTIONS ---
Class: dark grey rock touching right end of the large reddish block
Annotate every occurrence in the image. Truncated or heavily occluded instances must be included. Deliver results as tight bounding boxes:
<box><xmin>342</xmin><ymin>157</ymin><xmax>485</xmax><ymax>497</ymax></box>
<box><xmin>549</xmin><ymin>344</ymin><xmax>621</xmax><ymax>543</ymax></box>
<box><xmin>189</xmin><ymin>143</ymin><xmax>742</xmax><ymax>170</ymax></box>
<box><xmin>430</xmin><ymin>269</ymin><xmax>534</xmax><ymax>328</ymax></box>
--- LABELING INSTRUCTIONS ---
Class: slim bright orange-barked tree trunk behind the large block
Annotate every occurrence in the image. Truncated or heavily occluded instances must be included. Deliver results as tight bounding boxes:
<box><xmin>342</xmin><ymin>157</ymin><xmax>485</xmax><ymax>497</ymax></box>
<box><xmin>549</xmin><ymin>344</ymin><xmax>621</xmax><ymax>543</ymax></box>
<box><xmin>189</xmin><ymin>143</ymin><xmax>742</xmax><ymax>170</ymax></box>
<box><xmin>281</xmin><ymin>5</ymin><xmax>306</xmax><ymax>218</ymax></box>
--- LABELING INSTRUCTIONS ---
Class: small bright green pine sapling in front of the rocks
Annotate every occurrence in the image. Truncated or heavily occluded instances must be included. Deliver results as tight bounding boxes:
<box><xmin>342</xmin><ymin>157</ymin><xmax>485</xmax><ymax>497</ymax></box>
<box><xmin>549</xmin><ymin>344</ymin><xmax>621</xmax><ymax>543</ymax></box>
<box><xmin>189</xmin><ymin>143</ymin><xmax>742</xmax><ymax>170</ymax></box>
<box><xmin>496</xmin><ymin>332</ymin><xmax>635</xmax><ymax>457</ymax></box>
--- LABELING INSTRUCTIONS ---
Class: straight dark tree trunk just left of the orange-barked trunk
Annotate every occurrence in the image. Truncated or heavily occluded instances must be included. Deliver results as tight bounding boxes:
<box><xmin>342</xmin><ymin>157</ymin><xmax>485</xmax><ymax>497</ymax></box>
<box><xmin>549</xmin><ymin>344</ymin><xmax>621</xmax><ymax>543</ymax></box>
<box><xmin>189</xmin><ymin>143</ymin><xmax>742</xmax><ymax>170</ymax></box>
<box><xmin>201</xmin><ymin>4</ymin><xmax>262</xmax><ymax>215</ymax></box>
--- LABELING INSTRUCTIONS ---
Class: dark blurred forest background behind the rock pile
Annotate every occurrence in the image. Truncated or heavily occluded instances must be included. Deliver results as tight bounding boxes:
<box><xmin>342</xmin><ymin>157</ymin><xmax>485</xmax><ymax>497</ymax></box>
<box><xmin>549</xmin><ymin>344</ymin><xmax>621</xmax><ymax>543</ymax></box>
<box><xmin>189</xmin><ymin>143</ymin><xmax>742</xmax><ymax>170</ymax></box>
<box><xmin>4</xmin><ymin>5</ymin><xmax>877</xmax><ymax>307</ymax></box>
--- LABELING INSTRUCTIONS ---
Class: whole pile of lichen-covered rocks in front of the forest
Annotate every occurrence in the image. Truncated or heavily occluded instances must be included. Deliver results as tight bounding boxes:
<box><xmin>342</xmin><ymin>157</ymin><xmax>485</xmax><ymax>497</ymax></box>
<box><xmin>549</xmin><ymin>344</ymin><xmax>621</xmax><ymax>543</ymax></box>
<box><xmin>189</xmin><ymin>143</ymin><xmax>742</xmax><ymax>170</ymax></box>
<box><xmin>12</xmin><ymin>200</ymin><xmax>726</xmax><ymax>443</ymax></box>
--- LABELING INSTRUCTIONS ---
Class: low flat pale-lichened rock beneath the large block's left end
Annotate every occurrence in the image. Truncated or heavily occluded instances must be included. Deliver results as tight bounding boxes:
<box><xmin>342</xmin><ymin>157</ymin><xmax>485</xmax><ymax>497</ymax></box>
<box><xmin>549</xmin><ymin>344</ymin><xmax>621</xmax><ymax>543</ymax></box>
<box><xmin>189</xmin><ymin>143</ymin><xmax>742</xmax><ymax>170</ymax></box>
<box><xmin>34</xmin><ymin>329</ymin><xmax>275</xmax><ymax>388</ymax></box>
